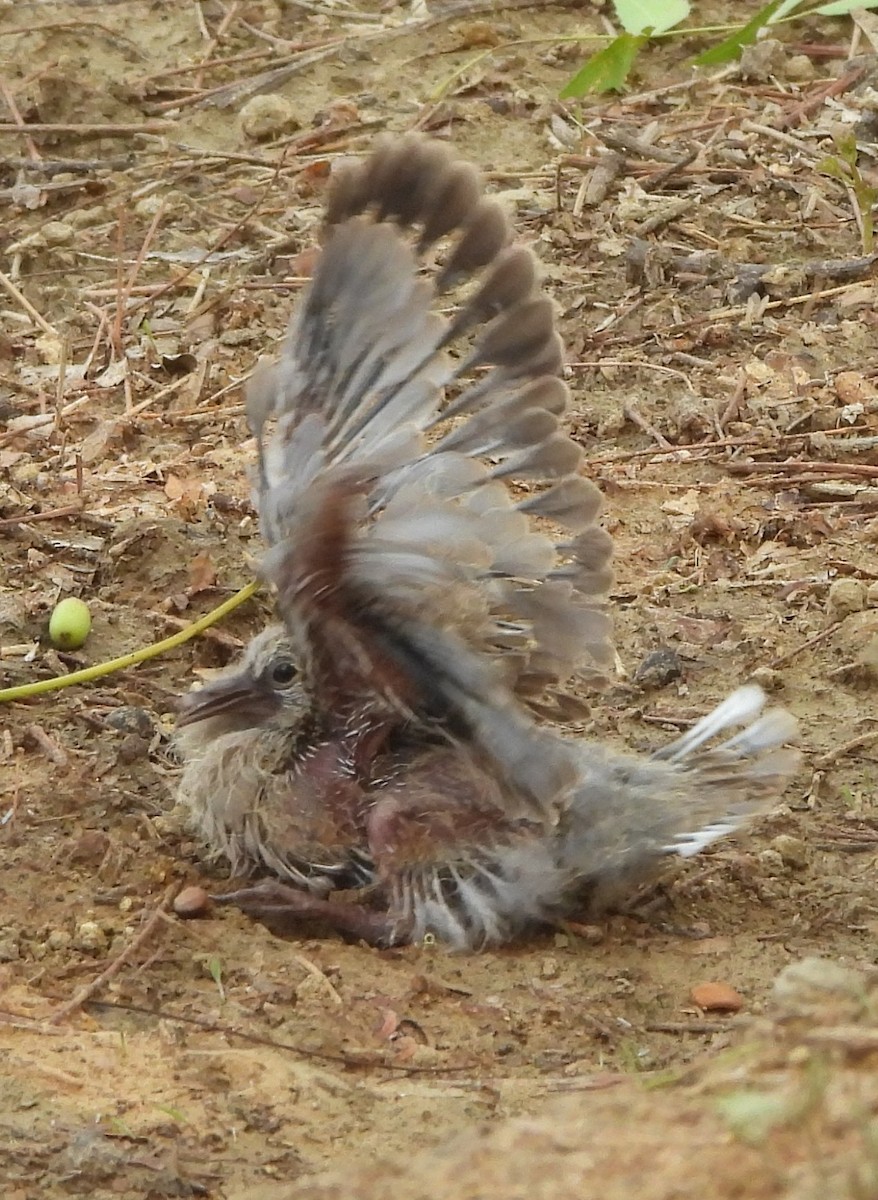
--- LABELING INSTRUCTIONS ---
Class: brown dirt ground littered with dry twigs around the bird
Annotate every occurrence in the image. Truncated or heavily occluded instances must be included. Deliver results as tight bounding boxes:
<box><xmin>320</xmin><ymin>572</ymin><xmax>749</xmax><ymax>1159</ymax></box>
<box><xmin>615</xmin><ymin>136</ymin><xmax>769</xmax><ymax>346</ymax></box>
<box><xmin>0</xmin><ymin>0</ymin><xmax>878</xmax><ymax>1200</ymax></box>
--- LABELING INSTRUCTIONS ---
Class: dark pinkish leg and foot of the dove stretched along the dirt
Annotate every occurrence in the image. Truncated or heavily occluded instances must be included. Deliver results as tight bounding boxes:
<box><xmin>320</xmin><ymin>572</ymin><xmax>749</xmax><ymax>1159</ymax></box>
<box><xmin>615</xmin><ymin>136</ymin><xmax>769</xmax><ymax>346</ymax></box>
<box><xmin>212</xmin><ymin>880</ymin><xmax>397</xmax><ymax>946</ymax></box>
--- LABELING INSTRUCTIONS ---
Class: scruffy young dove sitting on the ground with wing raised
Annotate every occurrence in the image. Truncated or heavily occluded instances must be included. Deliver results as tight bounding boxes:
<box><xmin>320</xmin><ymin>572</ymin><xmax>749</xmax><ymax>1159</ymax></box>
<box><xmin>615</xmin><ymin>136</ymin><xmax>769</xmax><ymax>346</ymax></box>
<box><xmin>178</xmin><ymin>136</ymin><xmax>799</xmax><ymax>949</ymax></box>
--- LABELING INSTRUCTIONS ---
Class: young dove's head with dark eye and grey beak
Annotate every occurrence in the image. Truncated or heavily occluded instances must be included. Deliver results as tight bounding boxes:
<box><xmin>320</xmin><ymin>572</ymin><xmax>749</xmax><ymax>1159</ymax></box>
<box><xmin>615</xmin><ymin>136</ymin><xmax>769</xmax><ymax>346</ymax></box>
<box><xmin>176</xmin><ymin>625</ymin><xmax>308</xmax><ymax>740</ymax></box>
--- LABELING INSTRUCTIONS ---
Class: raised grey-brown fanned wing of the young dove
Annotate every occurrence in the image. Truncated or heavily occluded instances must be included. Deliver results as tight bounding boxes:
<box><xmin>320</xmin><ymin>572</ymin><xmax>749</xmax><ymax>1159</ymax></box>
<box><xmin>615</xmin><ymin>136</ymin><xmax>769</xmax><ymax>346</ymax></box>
<box><xmin>248</xmin><ymin>137</ymin><xmax>612</xmax><ymax>811</ymax></box>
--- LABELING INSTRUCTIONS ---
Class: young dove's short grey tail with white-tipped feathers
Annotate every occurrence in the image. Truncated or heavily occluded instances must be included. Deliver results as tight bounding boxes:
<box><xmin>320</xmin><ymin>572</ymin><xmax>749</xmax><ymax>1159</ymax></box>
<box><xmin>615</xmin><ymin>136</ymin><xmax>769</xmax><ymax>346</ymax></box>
<box><xmin>558</xmin><ymin>684</ymin><xmax>801</xmax><ymax>886</ymax></box>
